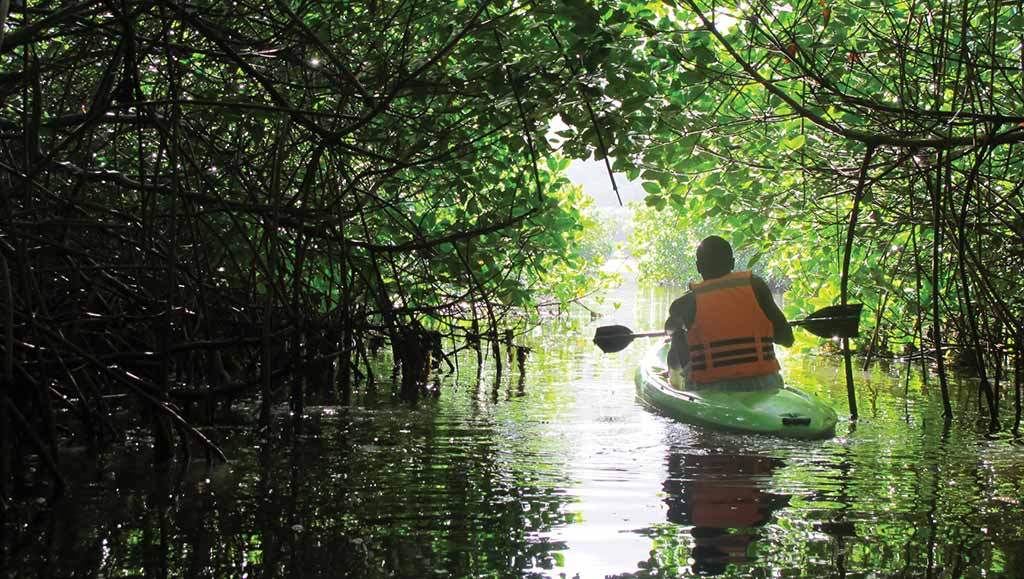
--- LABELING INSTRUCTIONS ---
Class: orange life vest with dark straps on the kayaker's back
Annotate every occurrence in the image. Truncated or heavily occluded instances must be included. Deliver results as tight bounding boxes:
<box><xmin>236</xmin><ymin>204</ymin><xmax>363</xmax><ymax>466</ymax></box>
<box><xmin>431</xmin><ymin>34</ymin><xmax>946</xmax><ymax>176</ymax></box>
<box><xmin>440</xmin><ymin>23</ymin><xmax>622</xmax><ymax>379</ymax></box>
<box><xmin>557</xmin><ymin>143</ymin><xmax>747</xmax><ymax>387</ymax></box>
<box><xmin>686</xmin><ymin>272</ymin><xmax>779</xmax><ymax>384</ymax></box>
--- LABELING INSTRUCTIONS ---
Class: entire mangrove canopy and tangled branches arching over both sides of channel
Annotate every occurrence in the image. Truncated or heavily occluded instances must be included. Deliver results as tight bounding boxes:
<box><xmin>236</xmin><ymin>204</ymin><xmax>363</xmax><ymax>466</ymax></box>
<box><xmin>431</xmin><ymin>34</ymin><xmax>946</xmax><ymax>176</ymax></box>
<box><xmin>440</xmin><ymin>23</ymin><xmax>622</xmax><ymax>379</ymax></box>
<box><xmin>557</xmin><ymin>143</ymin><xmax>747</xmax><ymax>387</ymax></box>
<box><xmin>0</xmin><ymin>0</ymin><xmax>1024</xmax><ymax>573</ymax></box>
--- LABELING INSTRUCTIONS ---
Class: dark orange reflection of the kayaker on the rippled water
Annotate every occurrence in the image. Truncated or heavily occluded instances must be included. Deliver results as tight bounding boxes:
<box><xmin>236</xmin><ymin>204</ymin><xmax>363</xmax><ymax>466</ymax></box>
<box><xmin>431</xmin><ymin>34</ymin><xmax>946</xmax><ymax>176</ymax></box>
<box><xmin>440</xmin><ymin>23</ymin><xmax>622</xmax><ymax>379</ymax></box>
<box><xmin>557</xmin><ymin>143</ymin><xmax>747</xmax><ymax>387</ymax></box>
<box><xmin>664</xmin><ymin>451</ymin><xmax>790</xmax><ymax>575</ymax></box>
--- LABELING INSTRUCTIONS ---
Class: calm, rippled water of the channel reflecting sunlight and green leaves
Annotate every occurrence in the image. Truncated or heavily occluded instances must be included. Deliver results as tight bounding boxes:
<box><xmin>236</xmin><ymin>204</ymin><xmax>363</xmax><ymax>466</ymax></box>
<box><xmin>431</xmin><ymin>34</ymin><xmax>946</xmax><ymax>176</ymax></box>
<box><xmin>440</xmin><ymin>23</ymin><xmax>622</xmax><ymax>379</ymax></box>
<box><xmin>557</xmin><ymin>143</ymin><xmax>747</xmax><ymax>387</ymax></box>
<box><xmin>3</xmin><ymin>282</ymin><xmax>1024</xmax><ymax>578</ymax></box>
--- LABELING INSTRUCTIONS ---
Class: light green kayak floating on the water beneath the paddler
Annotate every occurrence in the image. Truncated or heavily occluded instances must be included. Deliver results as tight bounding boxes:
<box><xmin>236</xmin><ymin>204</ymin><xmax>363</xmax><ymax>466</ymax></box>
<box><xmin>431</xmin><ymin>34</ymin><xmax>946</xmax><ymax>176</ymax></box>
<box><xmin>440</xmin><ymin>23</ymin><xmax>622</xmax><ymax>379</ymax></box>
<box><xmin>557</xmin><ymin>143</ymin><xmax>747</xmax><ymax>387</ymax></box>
<box><xmin>636</xmin><ymin>342</ymin><xmax>837</xmax><ymax>439</ymax></box>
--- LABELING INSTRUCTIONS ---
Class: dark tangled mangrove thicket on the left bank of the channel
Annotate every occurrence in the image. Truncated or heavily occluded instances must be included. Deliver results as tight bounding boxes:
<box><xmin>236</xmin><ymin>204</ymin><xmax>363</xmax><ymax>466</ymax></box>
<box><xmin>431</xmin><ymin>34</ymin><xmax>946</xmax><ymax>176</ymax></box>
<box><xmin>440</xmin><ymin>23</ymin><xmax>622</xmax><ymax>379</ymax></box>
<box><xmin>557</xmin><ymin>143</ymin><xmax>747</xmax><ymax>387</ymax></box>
<box><xmin>0</xmin><ymin>0</ymin><xmax>630</xmax><ymax>471</ymax></box>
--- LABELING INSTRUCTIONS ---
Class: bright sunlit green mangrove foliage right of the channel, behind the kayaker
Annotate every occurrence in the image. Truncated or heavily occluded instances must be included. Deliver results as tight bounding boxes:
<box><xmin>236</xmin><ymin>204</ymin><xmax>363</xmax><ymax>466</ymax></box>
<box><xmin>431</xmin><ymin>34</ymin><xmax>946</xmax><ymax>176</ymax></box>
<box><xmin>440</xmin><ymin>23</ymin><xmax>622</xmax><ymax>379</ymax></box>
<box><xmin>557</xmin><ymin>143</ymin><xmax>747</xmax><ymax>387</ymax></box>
<box><xmin>604</xmin><ymin>0</ymin><xmax>1024</xmax><ymax>383</ymax></box>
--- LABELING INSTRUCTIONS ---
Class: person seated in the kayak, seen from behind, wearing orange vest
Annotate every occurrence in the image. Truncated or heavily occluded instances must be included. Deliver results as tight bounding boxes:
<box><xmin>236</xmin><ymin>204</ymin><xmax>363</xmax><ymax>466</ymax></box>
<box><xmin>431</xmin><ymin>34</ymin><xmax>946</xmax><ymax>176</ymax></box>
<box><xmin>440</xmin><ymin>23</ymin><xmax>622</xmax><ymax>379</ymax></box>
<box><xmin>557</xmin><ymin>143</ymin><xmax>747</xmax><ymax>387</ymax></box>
<box><xmin>665</xmin><ymin>236</ymin><xmax>793</xmax><ymax>389</ymax></box>
